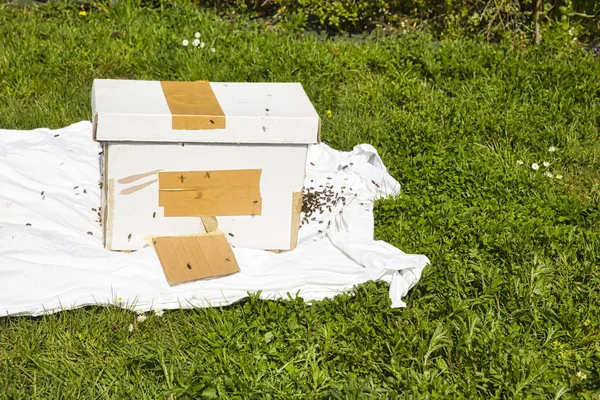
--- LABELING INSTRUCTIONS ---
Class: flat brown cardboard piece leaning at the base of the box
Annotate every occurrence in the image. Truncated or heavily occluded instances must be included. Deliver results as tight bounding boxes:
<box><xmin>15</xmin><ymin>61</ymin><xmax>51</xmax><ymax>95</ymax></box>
<box><xmin>152</xmin><ymin>231</ymin><xmax>240</xmax><ymax>285</ymax></box>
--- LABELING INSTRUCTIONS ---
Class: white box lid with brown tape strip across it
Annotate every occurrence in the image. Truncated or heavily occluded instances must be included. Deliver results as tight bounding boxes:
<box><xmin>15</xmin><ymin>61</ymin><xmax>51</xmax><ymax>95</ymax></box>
<box><xmin>92</xmin><ymin>79</ymin><xmax>320</xmax><ymax>144</ymax></box>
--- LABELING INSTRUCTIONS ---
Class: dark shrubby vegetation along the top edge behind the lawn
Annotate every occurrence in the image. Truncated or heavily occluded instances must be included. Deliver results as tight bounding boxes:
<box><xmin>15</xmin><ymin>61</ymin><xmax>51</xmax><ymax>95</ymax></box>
<box><xmin>10</xmin><ymin>0</ymin><xmax>600</xmax><ymax>41</ymax></box>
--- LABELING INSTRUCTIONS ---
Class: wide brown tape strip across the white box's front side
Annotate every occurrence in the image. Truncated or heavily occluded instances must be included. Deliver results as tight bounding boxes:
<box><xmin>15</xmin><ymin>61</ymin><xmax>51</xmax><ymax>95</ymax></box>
<box><xmin>158</xmin><ymin>169</ymin><xmax>262</xmax><ymax>217</ymax></box>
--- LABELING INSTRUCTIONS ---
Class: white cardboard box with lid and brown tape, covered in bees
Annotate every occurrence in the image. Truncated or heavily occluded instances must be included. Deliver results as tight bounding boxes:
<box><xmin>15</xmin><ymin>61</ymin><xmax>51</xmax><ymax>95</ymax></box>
<box><xmin>92</xmin><ymin>79</ymin><xmax>320</xmax><ymax>252</ymax></box>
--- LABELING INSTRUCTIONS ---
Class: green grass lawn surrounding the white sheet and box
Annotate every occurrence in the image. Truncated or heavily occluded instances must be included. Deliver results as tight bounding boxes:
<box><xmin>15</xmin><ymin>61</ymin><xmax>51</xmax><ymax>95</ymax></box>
<box><xmin>0</xmin><ymin>1</ymin><xmax>600</xmax><ymax>399</ymax></box>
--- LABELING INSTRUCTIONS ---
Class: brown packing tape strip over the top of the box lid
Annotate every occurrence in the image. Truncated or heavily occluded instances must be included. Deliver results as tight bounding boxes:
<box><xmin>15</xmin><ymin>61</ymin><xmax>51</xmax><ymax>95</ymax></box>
<box><xmin>160</xmin><ymin>81</ymin><xmax>226</xmax><ymax>130</ymax></box>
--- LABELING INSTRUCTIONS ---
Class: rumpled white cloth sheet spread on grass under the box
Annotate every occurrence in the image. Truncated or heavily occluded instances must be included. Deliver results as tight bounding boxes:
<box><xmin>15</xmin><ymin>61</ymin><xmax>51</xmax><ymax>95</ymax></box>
<box><xmin>0</xmin><ymin>121</ymin><xmax>429</xmax><ymax>317</ymax></box>
